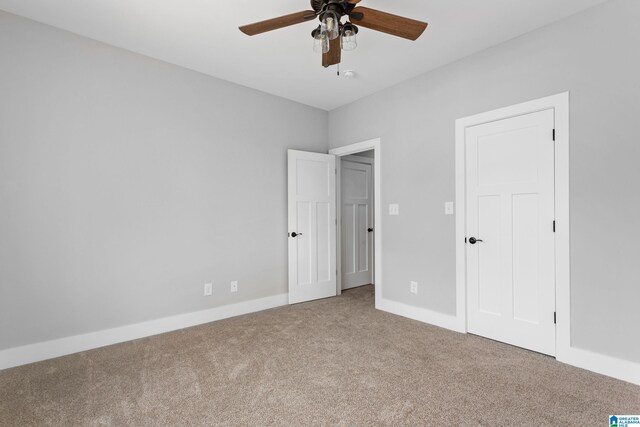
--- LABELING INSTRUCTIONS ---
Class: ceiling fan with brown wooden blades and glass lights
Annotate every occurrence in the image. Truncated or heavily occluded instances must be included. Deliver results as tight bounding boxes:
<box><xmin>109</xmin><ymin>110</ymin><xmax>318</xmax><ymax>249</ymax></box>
<box><xmin>240</xmin><ymin>0</ymin><xmax>427</xmax><ymax>67</ymax></box>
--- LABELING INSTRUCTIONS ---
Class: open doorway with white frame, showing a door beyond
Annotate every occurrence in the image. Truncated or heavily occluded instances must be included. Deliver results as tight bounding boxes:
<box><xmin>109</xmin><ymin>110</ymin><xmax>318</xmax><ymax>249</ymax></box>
<box><xmin>329</xmin><ymin>139</ymin><xmax>382</xmax><ymax>306</ymax></box>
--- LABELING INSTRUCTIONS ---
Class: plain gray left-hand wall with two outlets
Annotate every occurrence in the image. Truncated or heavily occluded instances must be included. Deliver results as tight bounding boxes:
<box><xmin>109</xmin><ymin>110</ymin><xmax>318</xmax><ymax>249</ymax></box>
<box><xmin>0</xmin><ymin>12</ymin><xmax>327</xmax><ymax>350</ymax></box>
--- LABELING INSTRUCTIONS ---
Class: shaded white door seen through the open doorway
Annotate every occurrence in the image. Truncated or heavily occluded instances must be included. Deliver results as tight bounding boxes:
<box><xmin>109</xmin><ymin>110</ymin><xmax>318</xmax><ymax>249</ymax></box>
<box><xmin>340</xmin><ymin>156</ymin><xmax>374</xmax><ymax>289</ymax></box>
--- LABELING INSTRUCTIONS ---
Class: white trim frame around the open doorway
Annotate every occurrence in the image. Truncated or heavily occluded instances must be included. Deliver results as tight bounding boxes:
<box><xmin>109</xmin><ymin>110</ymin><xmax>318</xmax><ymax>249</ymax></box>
<box><xmin>329</xmin><ymin>138</ymin><xmax>382</xmax><ymax>308</ymax></box>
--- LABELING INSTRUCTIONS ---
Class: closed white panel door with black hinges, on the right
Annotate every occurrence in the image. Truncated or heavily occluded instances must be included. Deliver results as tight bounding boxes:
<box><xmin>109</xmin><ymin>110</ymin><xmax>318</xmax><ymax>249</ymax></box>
<box><xmin>465</xmin><ymin>110</ymin><xmax>555</xmax><ymax>355</ymax></box>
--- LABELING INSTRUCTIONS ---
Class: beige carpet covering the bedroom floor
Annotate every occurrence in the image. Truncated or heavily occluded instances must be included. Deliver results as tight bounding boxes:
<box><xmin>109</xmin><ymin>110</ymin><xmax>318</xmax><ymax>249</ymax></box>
<box><xmin>0</xmin><ymin>286</ymin><xmax>640</xmax><ymax>426</ymax></box>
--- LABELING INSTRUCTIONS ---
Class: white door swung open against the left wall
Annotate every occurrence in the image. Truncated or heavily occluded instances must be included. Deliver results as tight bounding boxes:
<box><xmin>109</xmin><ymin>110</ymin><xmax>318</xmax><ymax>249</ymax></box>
<box><xmin>288</xmin><ymin>150</ymin><xmax>337</xmax><ymax>304</ymax></box>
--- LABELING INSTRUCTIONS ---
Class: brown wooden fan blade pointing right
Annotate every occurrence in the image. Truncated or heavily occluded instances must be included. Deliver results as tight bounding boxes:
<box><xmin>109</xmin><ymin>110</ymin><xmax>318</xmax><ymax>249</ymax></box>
<box><xmin>350</xmin><ymin>6</ymin><xmax>428</xmax><ymax>40</ymax></box>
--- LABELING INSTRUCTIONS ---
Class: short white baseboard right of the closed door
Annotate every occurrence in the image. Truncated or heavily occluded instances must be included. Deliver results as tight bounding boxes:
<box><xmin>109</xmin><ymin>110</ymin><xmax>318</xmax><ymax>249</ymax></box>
<box><xmin>556</xmin><ymin>347</ymin><xmax>640</xmax><ymax>385</ymax></box>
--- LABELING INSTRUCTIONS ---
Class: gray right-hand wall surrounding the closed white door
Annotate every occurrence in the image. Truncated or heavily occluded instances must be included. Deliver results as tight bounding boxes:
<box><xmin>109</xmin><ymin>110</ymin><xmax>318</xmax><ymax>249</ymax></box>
<box><xmin>329</xmin><ymin>0</ymin><xmax>640</xmax><ymax>362</ymax></box>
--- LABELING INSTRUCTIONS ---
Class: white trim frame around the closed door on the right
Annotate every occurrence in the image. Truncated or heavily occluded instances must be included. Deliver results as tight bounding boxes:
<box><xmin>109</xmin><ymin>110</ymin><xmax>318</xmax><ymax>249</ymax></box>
<box><xmin>455</xmin><ymin>92</ymin><xmax>571</xmax><ymax>360</ymax></box>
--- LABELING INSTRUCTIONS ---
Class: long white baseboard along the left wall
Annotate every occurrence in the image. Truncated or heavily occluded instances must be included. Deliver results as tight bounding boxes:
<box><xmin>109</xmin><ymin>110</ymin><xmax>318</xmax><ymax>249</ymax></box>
<box><xmin>0</xmin><ymin>294</ymin><xmax>289</xmax><ymax>370</ymax></box>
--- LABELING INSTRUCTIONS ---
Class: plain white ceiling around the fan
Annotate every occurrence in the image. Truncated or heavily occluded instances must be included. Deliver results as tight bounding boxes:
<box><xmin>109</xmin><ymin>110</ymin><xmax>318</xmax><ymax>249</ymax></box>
<box><xmin>0</xmin><ymin>0</ymin><xmax>605</xmax><ymax>110</ymax></box>
